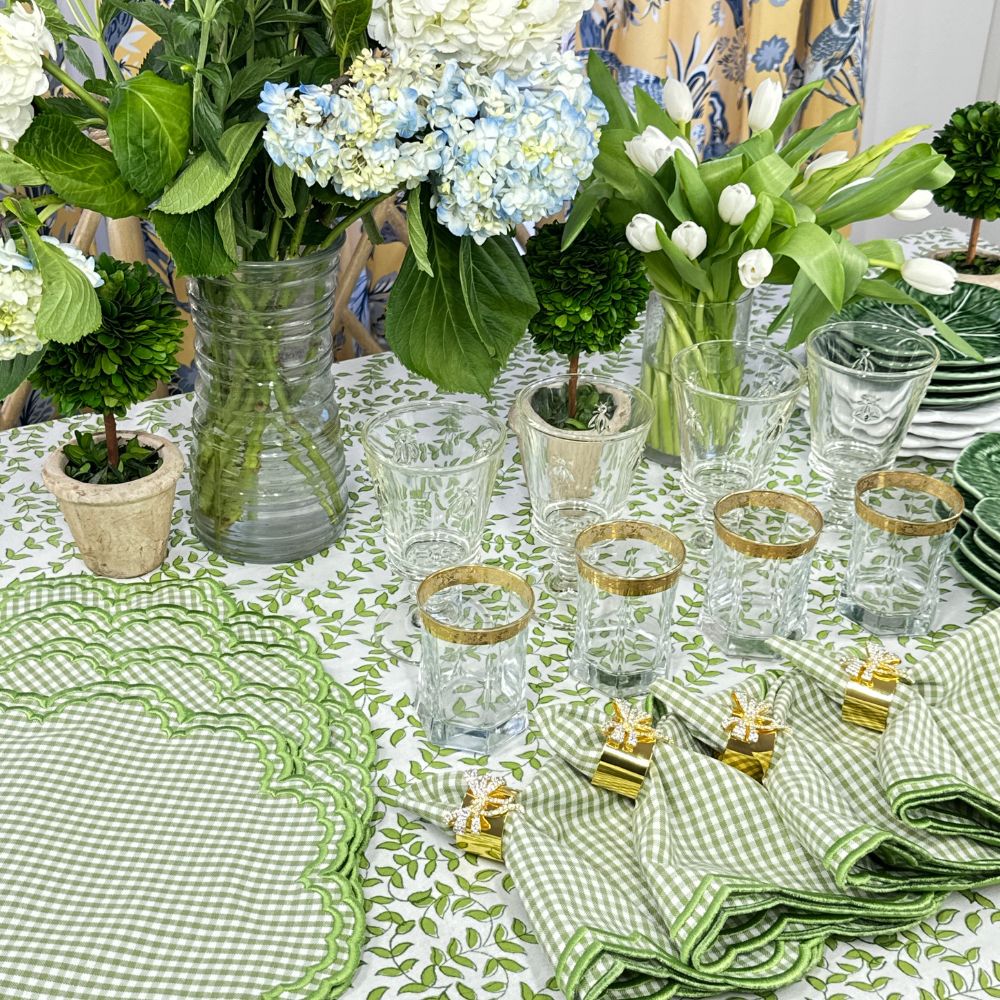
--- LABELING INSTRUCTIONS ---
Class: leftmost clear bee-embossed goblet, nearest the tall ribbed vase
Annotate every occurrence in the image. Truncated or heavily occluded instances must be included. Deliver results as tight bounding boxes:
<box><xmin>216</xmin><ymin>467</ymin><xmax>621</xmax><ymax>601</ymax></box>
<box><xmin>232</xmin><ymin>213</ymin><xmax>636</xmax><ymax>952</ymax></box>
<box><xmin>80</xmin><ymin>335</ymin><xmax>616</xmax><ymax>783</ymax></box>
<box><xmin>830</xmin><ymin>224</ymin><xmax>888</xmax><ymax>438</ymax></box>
<box><xmin>361</xmin><ymin>401</ymin><xmax>507</xmax><ymax>659</ymax></box>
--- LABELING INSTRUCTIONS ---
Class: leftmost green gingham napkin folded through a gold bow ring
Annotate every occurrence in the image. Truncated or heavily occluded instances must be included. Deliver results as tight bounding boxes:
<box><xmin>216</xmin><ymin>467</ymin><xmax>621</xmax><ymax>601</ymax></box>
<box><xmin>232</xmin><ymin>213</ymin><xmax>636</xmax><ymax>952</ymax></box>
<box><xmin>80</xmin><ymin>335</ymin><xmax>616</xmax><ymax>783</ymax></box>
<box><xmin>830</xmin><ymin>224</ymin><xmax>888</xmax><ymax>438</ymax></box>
<box><xmin>396</xmin><ymin>759</ymin><xmax>836</xmax><ymax>1000</ymax></box>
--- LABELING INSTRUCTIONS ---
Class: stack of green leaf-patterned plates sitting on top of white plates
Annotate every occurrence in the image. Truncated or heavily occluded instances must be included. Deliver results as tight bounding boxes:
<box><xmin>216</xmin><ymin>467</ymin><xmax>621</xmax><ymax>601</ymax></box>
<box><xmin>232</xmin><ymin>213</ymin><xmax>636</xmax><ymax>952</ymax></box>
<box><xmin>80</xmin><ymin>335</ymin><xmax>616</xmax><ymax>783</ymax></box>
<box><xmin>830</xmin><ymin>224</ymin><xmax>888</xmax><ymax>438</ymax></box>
<box><xmin>839</xmin><ymin>282</ymin><xmax>1000</xmax><ymax>409</ymax></box>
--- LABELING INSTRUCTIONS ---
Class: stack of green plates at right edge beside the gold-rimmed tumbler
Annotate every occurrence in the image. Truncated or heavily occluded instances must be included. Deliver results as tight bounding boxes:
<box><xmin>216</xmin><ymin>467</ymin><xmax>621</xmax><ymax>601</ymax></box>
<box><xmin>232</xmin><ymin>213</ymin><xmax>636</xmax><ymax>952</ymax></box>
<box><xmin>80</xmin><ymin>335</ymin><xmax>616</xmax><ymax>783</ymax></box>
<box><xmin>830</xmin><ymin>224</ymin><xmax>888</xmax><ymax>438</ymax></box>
<box><xmin>952</xmin><ymin>434</ymin><xmax>1000</xmax><ymax>601</ymax></box>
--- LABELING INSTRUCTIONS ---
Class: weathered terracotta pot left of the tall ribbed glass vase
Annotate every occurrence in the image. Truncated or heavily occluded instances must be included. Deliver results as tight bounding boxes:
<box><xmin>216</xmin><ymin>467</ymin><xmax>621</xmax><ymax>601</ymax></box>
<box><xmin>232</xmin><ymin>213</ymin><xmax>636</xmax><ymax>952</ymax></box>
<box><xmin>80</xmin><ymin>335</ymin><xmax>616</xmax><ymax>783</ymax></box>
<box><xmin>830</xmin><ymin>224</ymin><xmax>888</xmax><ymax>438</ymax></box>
<box><xmin>42</xmin><ymin>432</ymin><xmax>184</xmax><ymax>578</ymax></box>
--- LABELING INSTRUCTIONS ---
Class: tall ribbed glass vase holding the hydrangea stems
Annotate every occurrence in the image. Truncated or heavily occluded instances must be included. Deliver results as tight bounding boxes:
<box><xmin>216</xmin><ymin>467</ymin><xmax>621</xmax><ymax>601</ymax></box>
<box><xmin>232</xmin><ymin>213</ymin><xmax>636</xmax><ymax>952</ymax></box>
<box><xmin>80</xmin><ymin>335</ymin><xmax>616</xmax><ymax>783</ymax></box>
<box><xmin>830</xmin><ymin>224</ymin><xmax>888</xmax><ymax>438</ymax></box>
<box><xmin>188</xmin><ymin>247</ymin><xmax>347</xmax><ymax>563</ymax></box>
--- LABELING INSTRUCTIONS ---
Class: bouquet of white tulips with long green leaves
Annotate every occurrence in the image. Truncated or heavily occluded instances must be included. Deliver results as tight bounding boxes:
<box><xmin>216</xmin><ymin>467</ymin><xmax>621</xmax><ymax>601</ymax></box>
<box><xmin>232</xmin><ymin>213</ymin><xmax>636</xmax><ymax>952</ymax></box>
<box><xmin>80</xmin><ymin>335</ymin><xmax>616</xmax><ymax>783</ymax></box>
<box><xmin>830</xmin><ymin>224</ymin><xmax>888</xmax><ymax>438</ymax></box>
<box><xmin>565</xmin><ymin>57</ymin><xmax>974</xmax><ymax>456</ymax></box>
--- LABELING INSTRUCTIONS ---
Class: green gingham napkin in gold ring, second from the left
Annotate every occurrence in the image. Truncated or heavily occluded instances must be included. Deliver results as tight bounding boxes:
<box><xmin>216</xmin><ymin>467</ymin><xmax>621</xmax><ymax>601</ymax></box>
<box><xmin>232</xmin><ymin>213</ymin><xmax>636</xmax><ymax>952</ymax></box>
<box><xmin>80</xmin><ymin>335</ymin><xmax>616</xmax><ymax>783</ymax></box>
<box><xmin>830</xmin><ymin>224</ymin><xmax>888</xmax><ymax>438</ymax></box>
<box><xmin>536</xmin><ymin>706</ymin><xmax>939</xmax><ymax>975</ymax></box>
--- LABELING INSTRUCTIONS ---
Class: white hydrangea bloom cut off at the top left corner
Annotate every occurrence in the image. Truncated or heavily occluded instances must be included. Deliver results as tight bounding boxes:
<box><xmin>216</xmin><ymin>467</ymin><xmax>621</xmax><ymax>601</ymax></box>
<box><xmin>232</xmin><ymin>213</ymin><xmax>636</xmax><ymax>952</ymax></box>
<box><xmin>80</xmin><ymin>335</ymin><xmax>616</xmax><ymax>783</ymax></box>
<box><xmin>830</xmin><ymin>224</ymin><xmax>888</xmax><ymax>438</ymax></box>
<box><xmin>0</xmin><ymin>0</ymin><xmax>56</xmax><ymax>149</ymax></box>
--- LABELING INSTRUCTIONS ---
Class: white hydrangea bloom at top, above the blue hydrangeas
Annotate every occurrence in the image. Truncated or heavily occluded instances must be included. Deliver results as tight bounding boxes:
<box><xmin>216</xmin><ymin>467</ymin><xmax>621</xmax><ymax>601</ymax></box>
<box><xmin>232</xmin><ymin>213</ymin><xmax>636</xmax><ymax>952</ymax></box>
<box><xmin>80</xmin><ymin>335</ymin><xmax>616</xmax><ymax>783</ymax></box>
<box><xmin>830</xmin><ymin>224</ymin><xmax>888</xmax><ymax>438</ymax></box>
<box><xmin>368</xmin><ymin>0</ymin><xmax>593</xmax><ymax>75</ymax></box>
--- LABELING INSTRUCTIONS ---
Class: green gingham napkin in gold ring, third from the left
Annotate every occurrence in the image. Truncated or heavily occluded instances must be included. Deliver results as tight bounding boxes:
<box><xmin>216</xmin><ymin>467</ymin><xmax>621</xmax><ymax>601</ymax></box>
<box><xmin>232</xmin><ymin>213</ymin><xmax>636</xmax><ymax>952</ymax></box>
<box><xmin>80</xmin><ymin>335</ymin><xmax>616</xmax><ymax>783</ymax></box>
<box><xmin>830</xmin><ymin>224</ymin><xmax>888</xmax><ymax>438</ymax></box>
<box><xmin>653</xmin><ymin>671</ymin><xmax>1000</xmax><ymax>893</ymax></box>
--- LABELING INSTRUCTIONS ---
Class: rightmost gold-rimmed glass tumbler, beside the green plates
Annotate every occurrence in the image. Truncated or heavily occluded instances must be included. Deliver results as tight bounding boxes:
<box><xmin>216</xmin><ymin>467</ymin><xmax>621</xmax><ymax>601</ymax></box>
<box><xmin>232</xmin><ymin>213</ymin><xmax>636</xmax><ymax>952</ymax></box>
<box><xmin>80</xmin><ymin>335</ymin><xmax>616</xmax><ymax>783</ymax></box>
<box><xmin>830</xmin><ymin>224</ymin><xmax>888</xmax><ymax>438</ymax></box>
<box><xmin>837</xmin><ymin>471</ymin><xmax>965</xmax><ymax>635</ymax></box>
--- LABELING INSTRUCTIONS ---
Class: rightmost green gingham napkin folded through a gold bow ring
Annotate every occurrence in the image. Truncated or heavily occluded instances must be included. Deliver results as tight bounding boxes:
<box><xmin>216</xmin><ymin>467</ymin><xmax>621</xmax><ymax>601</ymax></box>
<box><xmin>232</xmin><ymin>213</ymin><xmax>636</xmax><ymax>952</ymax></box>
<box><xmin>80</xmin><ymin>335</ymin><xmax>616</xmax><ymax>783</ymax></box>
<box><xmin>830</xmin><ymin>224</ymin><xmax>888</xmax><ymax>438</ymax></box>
<box><xmin>774</xmin><ymin>611</ymin><xmax>1000</xmax><ymax>852</ymax></box>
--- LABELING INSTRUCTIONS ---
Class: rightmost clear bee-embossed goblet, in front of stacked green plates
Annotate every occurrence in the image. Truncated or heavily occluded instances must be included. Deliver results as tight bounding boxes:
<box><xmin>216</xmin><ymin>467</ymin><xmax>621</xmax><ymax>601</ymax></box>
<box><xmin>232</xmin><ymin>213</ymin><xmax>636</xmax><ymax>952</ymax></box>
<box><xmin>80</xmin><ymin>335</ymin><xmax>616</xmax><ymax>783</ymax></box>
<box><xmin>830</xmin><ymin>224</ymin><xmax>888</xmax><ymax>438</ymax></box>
<box><xmin>806</xmin><ymin>322</ymin><xmax>940</xmax><ymax>526</ymax></box>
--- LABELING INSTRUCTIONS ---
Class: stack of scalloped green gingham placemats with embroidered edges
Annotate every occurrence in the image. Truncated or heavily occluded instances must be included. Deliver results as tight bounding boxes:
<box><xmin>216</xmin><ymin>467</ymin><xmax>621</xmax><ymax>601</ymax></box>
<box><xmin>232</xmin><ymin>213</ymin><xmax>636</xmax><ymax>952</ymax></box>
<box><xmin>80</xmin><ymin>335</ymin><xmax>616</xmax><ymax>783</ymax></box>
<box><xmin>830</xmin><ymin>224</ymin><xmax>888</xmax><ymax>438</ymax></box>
<box><xmin>0</xmin><ymin>577</ymin><xmax>374</xmax><ymax>1000</ymax></box>
